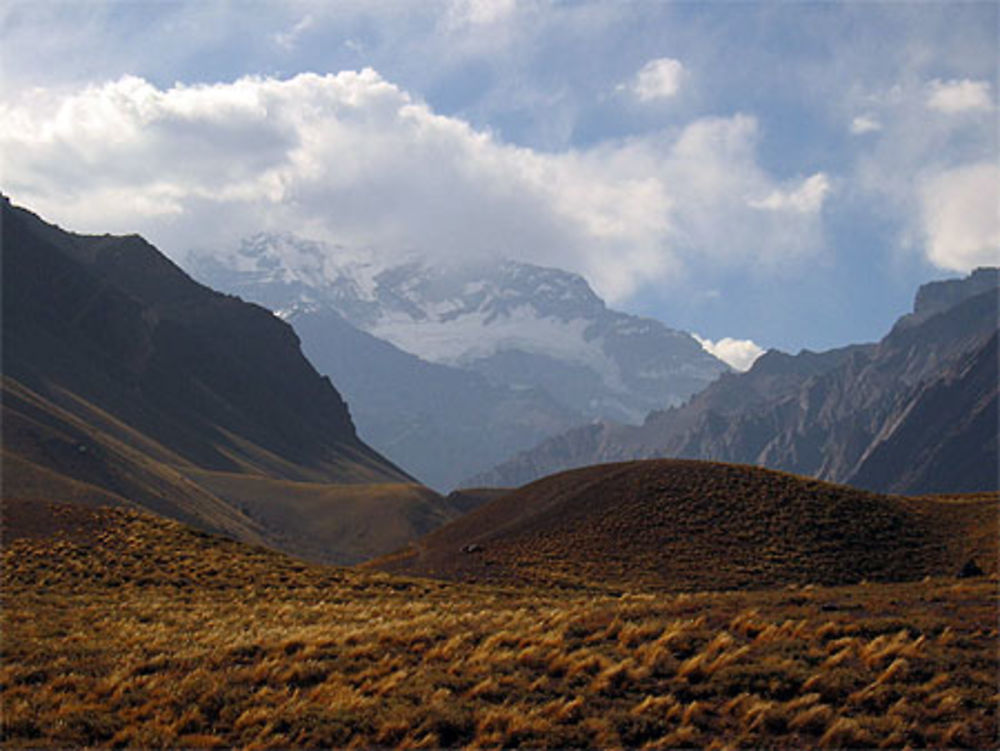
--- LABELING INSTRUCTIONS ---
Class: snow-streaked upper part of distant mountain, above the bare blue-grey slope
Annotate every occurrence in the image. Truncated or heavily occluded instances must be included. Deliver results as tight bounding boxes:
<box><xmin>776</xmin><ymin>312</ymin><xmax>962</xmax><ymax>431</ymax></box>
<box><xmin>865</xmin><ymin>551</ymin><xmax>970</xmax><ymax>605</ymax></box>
<box><xmin>193</xmin><ymin>234</ymin><xmax>728</xmax><ymax>423</ymax></box>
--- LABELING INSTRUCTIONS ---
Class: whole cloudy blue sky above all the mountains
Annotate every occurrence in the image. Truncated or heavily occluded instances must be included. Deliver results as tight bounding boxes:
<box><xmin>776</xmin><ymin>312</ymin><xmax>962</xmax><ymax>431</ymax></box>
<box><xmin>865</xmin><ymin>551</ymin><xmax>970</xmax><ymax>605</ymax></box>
<box><xmin>0</xmin><ymin>0</ymin><xmax>1000</xmax><ymax>366</ymax></box>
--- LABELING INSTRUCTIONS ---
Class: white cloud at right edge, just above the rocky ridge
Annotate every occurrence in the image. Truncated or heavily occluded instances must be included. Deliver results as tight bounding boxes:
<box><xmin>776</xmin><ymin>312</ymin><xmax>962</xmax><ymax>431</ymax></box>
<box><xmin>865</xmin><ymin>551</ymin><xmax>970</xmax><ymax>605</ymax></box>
<box><xmin>921</xmin><ymin>162</ymin><xmax>1000</xmax><ymax>271</ymax></box>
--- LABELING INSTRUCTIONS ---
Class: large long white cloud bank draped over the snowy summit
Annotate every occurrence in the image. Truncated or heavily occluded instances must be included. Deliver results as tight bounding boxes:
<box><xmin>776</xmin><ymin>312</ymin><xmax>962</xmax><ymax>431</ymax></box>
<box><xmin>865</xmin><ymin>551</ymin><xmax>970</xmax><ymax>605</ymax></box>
<box><xmin>0</xmin><ymin>69</ymin><xmax>828</xmax><ymax>302</ymax></box>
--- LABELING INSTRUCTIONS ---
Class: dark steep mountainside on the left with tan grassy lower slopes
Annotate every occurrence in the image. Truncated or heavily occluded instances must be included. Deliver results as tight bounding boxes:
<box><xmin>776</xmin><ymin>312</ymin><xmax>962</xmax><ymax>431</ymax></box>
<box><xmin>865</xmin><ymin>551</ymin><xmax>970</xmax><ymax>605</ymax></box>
<box><xmin>0</xmin><ymin>198</ymin><xmax>455</xmax><ymax>562</ymax></box>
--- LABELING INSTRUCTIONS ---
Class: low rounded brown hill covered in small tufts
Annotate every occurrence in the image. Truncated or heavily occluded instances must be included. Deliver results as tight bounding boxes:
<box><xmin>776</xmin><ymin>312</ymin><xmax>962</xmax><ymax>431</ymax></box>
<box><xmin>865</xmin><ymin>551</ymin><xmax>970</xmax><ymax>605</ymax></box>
<box><xmin>369</xmin><ymin>460</ymin><xmax>997</xmax><ymax>590</ymax></box>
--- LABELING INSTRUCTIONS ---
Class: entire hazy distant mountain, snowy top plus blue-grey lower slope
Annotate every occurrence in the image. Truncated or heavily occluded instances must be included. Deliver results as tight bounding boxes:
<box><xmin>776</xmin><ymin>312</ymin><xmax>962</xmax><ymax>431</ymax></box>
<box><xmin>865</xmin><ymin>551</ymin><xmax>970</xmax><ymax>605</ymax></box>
<box><xmin>188</xmin><ymin>234</ymin><xmax>729</xmax><ymax>489</ymax></box>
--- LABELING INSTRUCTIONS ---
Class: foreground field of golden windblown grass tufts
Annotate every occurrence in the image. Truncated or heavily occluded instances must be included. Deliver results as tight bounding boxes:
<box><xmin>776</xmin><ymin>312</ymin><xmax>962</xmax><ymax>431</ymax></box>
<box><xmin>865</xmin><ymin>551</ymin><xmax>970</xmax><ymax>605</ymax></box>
<box><xmin>0</xmin><ymin>504</ymin><xmax>998</xmax><ymax>748</ymax></box>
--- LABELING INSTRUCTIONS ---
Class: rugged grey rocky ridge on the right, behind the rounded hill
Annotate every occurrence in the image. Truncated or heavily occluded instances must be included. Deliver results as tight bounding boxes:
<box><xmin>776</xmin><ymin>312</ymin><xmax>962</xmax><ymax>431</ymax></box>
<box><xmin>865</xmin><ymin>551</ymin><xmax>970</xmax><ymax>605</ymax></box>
<box><xmin>467</xmin><ymin>269</ymin><xmax>1000</xmax><ymax>493</ymax></box>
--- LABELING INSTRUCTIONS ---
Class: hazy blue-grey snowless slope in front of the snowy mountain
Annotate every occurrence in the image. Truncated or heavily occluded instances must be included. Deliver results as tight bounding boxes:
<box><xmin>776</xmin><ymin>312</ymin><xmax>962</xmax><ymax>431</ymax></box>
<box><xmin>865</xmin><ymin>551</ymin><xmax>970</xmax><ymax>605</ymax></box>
<box><xmin>278</xmin><ymin>309</ymin><xmax>583</xmax><ymax>490</ymax></box>
